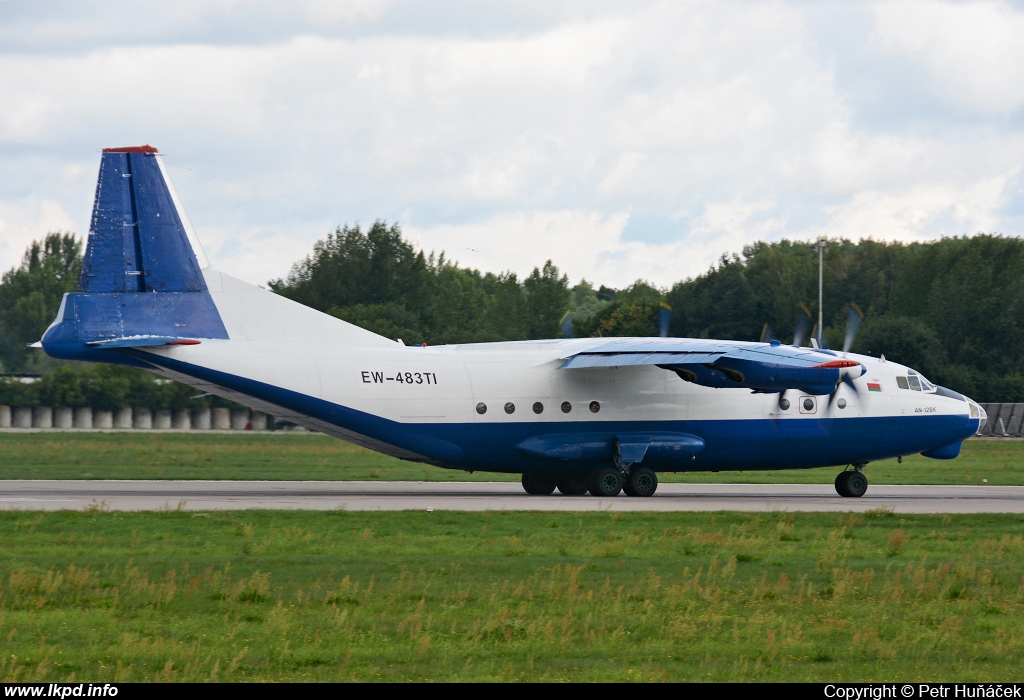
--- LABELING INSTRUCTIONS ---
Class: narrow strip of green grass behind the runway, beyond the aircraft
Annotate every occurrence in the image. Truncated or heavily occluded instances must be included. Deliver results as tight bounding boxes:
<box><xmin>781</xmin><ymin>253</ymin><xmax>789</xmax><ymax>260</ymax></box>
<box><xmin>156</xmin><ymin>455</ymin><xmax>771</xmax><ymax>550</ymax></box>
<box><xmin>0</xmin><ymin>433</ymin><xmax>1024</xmax><ymax>485</ymax></box>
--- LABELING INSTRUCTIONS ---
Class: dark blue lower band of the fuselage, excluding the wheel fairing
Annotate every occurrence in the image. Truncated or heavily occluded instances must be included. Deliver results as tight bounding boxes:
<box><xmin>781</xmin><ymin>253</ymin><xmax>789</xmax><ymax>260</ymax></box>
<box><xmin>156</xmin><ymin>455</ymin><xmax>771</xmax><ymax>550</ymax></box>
<box><xmin>92</xmin><ymin>350</ymin><xmax>978</xmax><ymax>473</ymax></box>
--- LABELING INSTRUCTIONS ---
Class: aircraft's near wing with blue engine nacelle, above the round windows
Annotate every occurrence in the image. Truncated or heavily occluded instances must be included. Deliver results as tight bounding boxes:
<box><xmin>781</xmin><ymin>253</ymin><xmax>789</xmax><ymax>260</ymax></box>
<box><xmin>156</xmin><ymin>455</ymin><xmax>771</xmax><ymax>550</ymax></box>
<box><xmin>558</xmin><ymin>339</ymin><xmax>866</xmax><ymax>394</ymax></box>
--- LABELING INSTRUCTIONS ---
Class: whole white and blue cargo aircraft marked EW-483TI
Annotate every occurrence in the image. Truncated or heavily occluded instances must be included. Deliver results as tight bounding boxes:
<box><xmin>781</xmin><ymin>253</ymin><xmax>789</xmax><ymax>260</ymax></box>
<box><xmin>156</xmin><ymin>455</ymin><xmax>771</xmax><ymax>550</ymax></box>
<box><xmin>41</xmin><ymin>146</ymin><xmax>985</xmax><ymax>497</ymax></box>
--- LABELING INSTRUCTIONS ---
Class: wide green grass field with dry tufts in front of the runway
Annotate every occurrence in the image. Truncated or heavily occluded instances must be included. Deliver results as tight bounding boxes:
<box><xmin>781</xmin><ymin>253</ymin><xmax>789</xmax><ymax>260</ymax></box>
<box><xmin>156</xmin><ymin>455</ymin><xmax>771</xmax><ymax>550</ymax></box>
<box><xmin>0</xmin><ymin>511</ymin><xmax>1024</xmax><ymax>682</ymax></box>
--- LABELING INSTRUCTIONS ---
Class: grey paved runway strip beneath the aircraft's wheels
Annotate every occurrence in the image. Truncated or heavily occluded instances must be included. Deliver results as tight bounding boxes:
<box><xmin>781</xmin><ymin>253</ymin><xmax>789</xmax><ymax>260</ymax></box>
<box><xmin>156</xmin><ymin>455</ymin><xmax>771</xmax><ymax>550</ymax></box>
<box><xmin>0</xmin><ymin>480</ymin><xmax>1024</xmax><ymax>513</ymax></box>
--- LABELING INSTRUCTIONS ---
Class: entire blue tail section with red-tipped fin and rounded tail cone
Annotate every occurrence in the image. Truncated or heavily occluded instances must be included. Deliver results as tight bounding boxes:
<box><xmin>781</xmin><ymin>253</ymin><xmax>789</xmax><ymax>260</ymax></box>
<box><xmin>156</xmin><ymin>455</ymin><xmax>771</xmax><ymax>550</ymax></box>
<box><xmin>42</xmin><ymin>145</ymin><xmax>228</xmax><ymax>361</ymax></box>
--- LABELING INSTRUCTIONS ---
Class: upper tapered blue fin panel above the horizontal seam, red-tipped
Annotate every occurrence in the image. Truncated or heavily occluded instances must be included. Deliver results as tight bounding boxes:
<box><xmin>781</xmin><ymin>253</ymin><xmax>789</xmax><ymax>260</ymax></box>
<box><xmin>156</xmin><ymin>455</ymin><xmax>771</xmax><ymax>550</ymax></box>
<box><xmin>80</xmin><ymin>145</ymin><xmax>207</xmax><ymax>292</ymax></box>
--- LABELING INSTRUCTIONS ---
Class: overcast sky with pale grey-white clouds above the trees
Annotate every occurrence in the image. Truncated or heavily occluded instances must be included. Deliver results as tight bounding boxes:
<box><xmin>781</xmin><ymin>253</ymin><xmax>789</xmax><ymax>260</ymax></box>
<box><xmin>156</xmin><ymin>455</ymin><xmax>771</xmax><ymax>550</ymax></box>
<box><xmin>0</xmin><ymin>0</ymin><xmax>1024</xmax><ymax>287</ymax></box>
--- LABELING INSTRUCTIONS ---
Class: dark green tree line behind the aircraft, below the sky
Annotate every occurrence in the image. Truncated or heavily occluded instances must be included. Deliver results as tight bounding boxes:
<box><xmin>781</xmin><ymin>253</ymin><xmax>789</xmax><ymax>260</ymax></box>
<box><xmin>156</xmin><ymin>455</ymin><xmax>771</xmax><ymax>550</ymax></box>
<box><xmin>0</xmin><ymin>221</ymin><xmax>1024</xmax><ymax>401</ymax></box>
